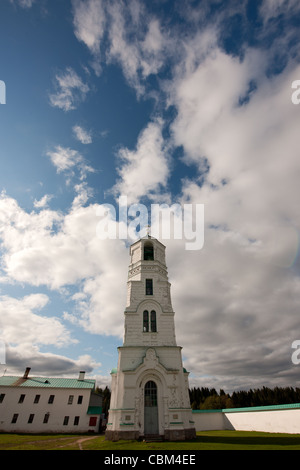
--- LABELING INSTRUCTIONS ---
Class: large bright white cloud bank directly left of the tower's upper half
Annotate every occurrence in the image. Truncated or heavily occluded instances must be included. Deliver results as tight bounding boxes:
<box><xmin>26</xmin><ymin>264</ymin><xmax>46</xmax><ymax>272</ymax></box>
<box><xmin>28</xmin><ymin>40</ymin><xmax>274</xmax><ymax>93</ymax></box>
<box><xmin>0</xmin><ymin>194</ymin><xmax>128</xmax><ymax>341</ymax></box>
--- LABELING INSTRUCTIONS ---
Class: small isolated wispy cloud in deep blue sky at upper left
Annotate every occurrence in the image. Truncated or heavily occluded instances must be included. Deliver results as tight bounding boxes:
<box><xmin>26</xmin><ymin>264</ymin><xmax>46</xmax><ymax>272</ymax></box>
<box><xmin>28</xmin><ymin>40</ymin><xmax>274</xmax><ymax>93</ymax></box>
<box><xmin>49</xmin><ymin>67</ymin><xmax>89</xmax><ymax>111</ymax></box>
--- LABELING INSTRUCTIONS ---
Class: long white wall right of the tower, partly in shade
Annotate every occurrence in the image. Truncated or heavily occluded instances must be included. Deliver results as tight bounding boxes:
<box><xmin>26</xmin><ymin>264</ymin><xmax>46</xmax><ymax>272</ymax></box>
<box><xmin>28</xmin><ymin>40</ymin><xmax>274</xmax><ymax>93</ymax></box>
<box><xmin>193</xmin><ymin>404</ymin><xmax>300</xmax><ymax>434</ymax></box>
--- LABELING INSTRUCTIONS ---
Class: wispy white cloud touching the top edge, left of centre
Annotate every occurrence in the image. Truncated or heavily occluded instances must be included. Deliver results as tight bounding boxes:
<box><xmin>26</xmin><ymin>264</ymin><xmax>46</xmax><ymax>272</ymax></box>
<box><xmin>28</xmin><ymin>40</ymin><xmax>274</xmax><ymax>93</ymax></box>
<box><xmin>73</xmin><ymin>0</ymin><xmax>169</xmax><ymax>96</ymax></box>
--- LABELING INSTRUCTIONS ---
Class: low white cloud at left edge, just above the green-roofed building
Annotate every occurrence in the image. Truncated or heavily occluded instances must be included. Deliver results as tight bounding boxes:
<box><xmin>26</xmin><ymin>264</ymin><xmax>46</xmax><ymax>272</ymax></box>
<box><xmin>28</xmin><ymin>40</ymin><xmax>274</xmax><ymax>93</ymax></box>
<box><xmin>0</xmin><ymin>293</ymin><xmax>92</xmax><ymax>376</ymax></box>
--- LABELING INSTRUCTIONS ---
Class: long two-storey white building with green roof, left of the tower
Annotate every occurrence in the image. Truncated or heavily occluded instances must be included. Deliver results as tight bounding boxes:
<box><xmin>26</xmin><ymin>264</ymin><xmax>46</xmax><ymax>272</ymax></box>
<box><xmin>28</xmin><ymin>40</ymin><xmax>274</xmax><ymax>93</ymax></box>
<box><xmin>0</xmin><ymin>368</ymin><xmax>102</xmax><ymax>433</ymax></box>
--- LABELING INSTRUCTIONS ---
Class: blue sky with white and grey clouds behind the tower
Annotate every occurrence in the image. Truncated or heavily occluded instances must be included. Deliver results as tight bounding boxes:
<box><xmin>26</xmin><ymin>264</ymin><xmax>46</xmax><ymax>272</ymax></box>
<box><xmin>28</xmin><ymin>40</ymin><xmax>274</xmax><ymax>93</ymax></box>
<box><xmin>0</xmin><ymin>0</ymin><xmax>300</xmax><ymax>390</ymax></box>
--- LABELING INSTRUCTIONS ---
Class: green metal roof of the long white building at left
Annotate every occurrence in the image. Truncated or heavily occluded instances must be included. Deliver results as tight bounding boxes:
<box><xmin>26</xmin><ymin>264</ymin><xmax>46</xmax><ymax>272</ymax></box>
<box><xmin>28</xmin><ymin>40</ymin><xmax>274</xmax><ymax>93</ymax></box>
<box><xmin>0</xmin><ymin>376</ymin><xmax>96</xmax><ymax>390</ymax></box>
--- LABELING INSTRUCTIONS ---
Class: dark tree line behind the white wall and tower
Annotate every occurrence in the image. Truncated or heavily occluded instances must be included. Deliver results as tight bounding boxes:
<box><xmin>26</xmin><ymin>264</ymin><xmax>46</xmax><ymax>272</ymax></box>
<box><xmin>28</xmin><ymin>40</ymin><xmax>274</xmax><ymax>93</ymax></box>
<box><xmin>96</xmin><ymin>387</ymin><xmax>300</xmax><ymax>417</ymax></box>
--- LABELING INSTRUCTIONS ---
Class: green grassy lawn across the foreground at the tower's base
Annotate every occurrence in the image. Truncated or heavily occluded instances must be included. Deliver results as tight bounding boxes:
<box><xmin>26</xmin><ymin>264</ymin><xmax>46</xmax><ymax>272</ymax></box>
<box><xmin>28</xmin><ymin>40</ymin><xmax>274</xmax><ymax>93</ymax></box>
<box><xmin>0</xmin><ymin>431</ymin><xmax>300</xmax><ymax>451</ymax></box>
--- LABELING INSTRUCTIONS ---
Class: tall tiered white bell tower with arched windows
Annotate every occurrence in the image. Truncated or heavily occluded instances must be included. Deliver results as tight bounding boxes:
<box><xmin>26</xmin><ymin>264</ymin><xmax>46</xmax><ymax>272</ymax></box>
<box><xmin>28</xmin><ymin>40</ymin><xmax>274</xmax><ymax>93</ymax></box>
<box><xmin>106</xmin><ymin>239</ymin><xmax>195</xmax><ymax>440</ymax></box>
